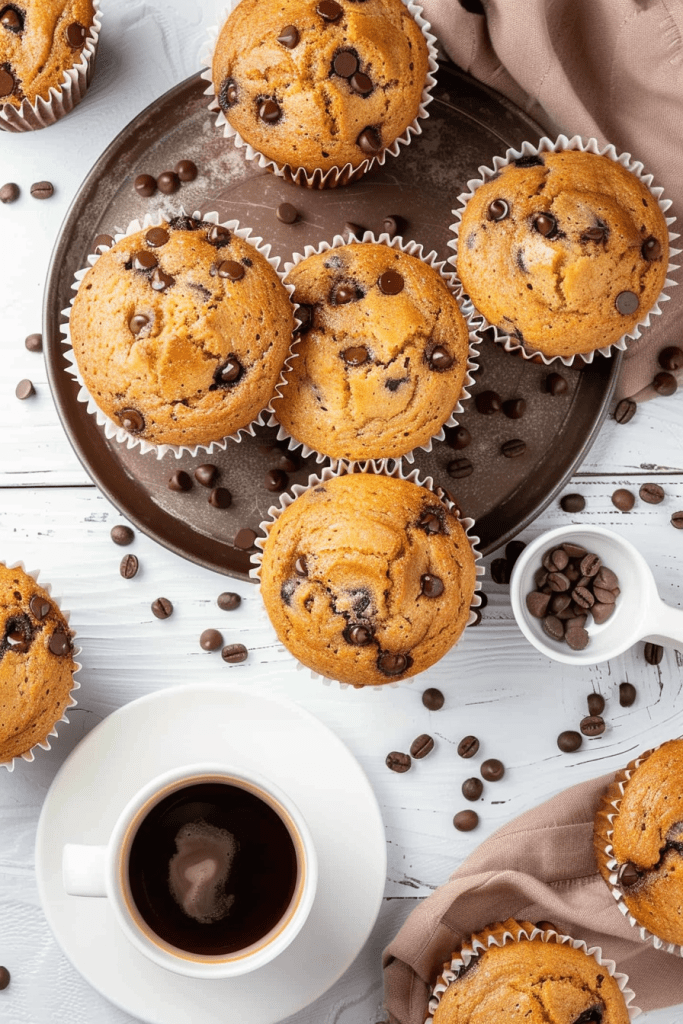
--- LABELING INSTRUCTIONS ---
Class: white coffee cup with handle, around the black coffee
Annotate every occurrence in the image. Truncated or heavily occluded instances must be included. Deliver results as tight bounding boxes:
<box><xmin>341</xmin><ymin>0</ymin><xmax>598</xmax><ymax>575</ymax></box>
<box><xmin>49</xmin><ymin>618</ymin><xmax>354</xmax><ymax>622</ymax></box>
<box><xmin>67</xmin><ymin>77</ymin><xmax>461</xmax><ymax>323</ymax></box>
<box><xmin>62</xmin><ymin>764</ymin><xmax>317</xmax><ymax>979</ymax></box>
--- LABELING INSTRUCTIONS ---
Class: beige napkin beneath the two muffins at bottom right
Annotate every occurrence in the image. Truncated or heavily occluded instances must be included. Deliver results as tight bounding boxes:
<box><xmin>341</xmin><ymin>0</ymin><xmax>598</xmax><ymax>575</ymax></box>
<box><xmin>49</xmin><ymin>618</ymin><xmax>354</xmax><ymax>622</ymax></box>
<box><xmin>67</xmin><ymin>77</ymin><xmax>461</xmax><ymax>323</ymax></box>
<box><xmin>384</xmin><ymin>775</ymin><xmax>683</xmax><ymax>1024</ymax></box>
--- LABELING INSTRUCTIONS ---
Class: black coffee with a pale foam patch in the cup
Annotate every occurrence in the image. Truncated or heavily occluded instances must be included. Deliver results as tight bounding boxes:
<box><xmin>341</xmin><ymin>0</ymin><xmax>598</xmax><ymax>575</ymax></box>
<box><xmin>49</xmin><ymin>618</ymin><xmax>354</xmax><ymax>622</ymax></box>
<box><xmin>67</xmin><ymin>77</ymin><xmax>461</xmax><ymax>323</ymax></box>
<box><xmin>128</xmin><ymin>782</ymin><xmax>297</xmax><ymax>955</ymax></box>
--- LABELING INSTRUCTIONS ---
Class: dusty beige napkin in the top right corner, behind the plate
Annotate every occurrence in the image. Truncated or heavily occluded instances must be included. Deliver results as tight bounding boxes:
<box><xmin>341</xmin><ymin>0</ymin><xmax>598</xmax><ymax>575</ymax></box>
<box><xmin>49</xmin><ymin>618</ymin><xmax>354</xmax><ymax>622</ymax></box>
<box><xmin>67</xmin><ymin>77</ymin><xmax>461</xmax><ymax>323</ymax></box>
<box><xmin>421</xmin><ymin>0</ymin><xmax>683</xmax><ymax>397</ymax></box>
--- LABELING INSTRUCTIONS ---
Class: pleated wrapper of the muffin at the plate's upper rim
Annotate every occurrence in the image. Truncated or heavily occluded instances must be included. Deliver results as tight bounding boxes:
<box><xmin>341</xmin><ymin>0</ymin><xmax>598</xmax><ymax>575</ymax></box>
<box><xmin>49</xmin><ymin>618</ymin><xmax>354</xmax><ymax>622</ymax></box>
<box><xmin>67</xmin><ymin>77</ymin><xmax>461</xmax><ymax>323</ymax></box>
<box><xmin>201</xmin><ymin>0</ymin><xmax>438</xmax><ymax>188</ymax></box>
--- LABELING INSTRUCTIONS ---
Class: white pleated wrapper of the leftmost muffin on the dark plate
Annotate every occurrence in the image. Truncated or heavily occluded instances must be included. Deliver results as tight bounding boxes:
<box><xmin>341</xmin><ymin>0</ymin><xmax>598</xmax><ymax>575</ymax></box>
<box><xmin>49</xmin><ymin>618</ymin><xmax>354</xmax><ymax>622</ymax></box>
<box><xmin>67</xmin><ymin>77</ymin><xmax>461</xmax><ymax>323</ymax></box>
<box><xmin>59</xmin><ymin>207</ymin><xmax>299</xmax><ymax>459</ymax></box>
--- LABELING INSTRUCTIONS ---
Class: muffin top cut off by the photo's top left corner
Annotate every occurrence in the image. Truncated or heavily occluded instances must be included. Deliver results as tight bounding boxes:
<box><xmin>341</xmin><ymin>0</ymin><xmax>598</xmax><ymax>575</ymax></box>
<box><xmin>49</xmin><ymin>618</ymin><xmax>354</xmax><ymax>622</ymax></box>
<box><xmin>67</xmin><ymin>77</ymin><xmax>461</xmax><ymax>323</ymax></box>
<box><xmin>0</xmin><ymin>0</ymin><xmax>94</xmax><ymax>106</ymax></box>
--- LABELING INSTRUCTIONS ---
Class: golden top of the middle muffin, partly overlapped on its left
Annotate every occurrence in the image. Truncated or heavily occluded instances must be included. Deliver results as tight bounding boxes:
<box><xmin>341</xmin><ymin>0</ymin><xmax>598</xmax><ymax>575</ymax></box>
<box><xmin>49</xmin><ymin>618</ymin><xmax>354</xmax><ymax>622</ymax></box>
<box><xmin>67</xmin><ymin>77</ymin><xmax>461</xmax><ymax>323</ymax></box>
<box><xmin>272</xmin><ymin>243</ymin><xmax>469</xmax><ymax>460</ymax></box>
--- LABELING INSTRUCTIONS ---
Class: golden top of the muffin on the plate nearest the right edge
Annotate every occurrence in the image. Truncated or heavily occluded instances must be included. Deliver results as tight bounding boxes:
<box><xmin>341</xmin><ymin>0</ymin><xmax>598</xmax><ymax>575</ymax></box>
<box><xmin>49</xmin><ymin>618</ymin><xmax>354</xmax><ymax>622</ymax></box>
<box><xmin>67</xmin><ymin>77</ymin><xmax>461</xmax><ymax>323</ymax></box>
<box><xmin>458</xmin><ymin>151</ymin><xmax>669</xmax><ymax>356</ymax></box>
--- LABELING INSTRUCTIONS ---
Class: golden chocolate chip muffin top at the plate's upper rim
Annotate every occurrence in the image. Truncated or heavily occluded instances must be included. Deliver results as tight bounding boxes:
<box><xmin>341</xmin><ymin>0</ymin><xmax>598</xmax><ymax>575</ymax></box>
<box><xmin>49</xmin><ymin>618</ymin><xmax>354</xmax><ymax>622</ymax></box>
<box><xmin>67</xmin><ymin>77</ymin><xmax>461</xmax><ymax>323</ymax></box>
<box><xmin>212</xmin><ymin>0</ymin><xmax>429</xmax><ymax>172</ymax></box>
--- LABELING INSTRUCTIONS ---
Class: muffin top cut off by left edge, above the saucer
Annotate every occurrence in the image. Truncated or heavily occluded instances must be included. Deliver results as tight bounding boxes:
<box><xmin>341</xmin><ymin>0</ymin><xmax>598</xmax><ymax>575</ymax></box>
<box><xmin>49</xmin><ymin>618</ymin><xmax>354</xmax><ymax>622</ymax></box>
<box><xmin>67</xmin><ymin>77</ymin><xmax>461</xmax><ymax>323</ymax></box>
<box><xmin>0</xmin><ymin>563</ymin><xmax>76</xmax><ymax>762</ymax></box>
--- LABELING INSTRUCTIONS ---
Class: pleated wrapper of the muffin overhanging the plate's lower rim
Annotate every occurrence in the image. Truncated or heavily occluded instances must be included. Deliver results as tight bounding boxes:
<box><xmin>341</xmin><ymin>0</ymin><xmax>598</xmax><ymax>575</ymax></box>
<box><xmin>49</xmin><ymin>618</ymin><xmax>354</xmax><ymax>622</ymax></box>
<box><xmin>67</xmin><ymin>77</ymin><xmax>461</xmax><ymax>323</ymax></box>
<box><xmin>249</xmin><ymin>460</ymin><xmax>485</xmax><ymax>690</ymax></box>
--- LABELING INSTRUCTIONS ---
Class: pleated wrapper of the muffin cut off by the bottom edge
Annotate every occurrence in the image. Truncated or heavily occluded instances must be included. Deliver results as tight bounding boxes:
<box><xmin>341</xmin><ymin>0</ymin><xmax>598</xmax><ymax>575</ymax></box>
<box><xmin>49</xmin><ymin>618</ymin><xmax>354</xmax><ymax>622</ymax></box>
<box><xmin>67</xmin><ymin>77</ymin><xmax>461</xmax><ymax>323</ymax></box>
<box><xmin>425</xmin><ymin>922</ymin><xmax>642</xmax><ymax>1024</ymax></box>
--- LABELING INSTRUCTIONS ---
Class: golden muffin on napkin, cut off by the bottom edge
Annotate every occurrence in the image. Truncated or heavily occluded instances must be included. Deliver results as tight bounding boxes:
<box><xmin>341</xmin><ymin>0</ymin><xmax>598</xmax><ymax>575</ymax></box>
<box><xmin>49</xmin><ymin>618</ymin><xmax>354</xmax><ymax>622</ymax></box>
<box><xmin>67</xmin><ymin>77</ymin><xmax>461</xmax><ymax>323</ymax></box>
<box><xmin>433</xmin><ymin>920</ymin><xmax>629</xmax><ymax>1024</ymax></box>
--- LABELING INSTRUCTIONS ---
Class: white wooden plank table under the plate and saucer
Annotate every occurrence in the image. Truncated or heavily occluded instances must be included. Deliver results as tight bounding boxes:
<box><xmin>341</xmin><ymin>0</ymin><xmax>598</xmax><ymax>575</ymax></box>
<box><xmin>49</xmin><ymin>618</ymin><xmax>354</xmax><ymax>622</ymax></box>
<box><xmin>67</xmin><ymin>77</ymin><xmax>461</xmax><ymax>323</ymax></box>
<box><xmin>0</xmin><ymin>0</ymin><xmax>683</xmax><ymax>1024</ymax></box>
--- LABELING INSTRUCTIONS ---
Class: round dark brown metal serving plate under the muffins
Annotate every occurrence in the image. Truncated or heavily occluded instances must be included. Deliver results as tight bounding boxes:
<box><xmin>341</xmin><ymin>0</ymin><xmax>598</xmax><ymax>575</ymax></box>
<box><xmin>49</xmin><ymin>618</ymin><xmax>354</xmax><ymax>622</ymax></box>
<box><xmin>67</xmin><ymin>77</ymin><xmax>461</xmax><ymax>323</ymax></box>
<box><xmin>43</xmin><ymin>63</ymin><xmax>621</xmax><ymax>579</ymax></box>
